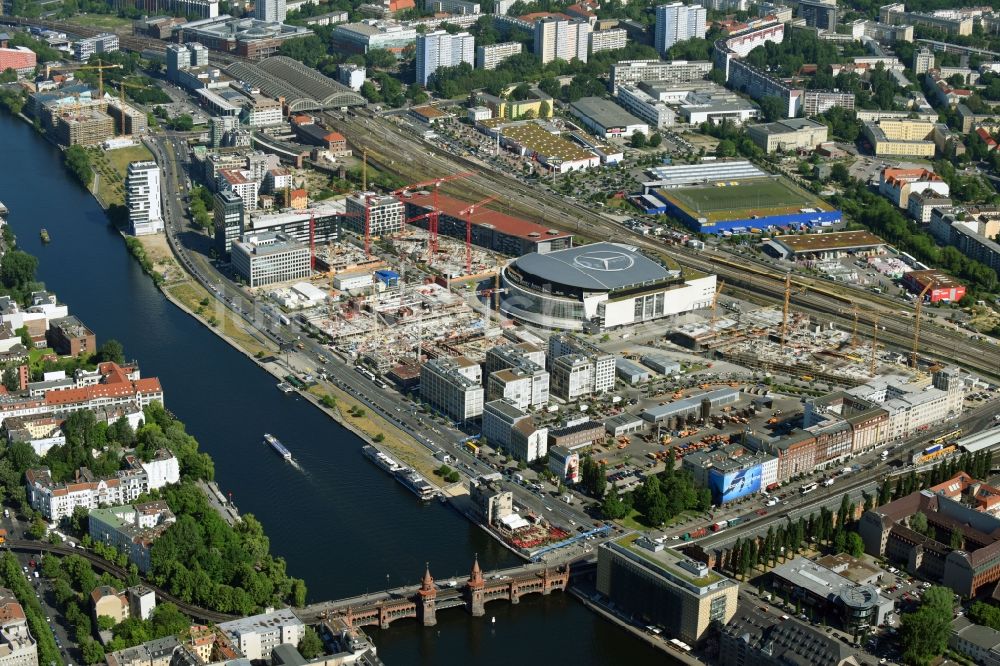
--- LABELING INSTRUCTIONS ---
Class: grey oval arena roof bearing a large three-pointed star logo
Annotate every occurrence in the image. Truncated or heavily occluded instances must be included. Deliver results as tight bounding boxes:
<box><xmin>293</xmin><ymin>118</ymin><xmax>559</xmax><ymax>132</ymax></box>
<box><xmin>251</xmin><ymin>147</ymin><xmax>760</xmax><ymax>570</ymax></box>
<box><xmin>511</xmin><ymin>243</ymin><xmax>673</xmax><ymax>292</ymax></box>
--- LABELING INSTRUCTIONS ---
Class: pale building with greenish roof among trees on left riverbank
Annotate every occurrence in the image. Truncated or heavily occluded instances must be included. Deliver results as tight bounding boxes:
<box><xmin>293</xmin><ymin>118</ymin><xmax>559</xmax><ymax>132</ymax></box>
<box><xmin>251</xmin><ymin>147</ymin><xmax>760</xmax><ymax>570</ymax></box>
<box><xmin>87</xmin><ymin>500</ymin><xmax>177</xmax><ymax>573</ymax></box>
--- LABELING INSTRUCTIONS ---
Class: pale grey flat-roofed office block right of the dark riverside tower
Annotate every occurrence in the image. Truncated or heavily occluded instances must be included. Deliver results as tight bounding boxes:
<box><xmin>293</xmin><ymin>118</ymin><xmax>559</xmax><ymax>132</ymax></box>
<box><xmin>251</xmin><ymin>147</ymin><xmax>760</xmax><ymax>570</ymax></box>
<box><xmin>230</xmin><ymin>232</ymin><xmax>312</xmax><ymax>287</ymax></box>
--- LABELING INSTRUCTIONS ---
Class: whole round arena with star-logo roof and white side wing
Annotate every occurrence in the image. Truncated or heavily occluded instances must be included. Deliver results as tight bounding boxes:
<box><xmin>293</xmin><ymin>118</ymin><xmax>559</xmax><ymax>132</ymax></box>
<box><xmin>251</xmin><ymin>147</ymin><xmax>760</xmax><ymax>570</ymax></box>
<box><xmin>500</xmin><ymin>243</ymin><xmax>715</xmax><ymax>332</ymax></box>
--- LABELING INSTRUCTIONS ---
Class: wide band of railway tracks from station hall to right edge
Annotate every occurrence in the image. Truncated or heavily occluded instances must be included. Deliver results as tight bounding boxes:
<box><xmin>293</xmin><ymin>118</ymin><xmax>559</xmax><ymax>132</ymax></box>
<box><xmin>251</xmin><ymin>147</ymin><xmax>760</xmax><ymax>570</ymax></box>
<box><xmin>334</xmin><ymin>110</ymin><xmax>1000</xmax><ymax>379</ymax></box>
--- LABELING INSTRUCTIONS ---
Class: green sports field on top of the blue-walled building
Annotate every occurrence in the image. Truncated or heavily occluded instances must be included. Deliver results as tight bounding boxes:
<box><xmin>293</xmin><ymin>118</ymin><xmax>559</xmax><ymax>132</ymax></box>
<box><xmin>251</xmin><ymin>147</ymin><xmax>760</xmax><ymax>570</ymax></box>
<box><xmin>660</xmin><ymin>178</ymin><xmax>831</xmax><ymax>222</ymax></box>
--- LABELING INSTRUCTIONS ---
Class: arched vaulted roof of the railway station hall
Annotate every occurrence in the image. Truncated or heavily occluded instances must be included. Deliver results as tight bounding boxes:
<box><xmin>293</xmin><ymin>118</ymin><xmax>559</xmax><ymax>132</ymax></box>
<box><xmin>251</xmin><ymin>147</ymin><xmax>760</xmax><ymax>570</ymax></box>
<box><xmin>226</xmin><ymin>56</ymin><xmax>365</xmax><ymax>111</ymax></box>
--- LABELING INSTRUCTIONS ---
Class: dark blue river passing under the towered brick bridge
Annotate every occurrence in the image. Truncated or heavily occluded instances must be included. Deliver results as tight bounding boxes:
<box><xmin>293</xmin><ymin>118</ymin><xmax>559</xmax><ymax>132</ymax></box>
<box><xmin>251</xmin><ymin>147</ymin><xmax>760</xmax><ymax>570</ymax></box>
<box><xmin>0</xmin><ymin>113</ymin><xmax>665</xmax><ymax>666</ymax></box>
